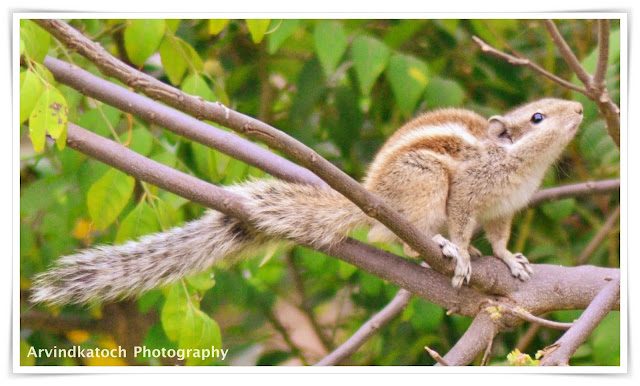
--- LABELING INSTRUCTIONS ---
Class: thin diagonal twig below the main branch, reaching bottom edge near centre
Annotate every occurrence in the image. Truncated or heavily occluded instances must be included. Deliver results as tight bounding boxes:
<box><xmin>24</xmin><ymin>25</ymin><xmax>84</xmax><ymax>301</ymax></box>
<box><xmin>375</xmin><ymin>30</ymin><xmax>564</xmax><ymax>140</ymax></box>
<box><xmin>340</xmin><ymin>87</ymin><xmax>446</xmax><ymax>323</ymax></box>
<box><xmin>315</xmin><ymin>289</ymin><xmax>411</xmax><ymax>366</ymax></box>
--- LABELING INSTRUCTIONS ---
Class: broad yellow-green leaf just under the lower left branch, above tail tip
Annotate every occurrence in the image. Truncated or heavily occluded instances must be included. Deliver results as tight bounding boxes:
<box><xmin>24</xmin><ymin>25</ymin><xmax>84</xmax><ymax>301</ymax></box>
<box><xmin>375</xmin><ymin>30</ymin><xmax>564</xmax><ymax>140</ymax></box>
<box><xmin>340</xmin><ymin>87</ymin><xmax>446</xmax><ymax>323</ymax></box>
<box><xmin>87</xmin><ymin>169</ymin><xmax>135</xmax><ymax>230</ymax></box>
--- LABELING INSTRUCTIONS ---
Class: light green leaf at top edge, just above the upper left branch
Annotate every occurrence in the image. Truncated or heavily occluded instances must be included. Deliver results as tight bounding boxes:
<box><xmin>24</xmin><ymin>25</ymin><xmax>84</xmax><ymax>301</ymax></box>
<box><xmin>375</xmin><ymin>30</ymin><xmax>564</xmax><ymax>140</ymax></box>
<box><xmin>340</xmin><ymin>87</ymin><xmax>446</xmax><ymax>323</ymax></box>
<box><xmin>124</xmin><ymin>19</ymin><xmax>166</xmax><ymax>66</ymax></box>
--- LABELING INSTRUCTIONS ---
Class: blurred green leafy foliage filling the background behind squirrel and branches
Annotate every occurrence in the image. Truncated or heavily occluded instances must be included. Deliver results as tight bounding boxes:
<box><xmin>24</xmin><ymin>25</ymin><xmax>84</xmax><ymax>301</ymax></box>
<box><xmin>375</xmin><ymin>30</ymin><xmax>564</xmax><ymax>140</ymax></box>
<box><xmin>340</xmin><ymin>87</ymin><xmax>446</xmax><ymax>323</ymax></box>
<box><xmin>20</xmin><ymin>20</ymin><xmax>620</xmax><ymax>365</ymax></box>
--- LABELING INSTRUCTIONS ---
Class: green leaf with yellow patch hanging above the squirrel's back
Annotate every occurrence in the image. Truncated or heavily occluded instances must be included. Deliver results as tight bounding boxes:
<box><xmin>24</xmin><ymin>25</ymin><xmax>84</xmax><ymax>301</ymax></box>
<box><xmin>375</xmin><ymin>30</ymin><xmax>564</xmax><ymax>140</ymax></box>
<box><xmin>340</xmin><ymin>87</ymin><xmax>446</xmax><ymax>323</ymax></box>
<box><xmin>387</xmin><ymin>54</ymin><xmax>429</xmax><ymax>117</ymax></box>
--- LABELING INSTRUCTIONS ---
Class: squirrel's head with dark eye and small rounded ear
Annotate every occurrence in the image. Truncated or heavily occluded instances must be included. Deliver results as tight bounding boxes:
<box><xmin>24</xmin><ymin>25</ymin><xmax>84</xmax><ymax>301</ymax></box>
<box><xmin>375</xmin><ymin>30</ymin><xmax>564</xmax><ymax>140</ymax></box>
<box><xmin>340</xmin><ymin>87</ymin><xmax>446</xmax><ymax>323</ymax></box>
<box><xmin>489</xmin><ymin>98</ymin><xmax>582</xmax><ymax>147</ymax></box>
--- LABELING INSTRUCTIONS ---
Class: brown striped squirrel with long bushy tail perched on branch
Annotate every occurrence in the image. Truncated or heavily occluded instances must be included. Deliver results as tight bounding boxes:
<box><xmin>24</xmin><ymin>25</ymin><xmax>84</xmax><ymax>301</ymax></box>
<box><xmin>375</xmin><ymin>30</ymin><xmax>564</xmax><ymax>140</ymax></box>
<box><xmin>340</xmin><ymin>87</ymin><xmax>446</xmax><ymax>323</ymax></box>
<box><xmin>31</xmin><ymin>98</ymin><xmax>583</xmax><ymax>305</ymax></box>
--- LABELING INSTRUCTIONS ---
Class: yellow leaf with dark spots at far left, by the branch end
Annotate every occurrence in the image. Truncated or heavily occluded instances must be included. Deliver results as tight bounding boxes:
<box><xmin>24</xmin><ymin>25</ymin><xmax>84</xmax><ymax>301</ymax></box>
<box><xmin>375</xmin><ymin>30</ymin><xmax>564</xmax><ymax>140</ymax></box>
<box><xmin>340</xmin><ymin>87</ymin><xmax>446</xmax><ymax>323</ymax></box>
<box><xmin>29</xmin><ymin>86</ymin><xmax>69</xmax><ymax>152</ymax></box>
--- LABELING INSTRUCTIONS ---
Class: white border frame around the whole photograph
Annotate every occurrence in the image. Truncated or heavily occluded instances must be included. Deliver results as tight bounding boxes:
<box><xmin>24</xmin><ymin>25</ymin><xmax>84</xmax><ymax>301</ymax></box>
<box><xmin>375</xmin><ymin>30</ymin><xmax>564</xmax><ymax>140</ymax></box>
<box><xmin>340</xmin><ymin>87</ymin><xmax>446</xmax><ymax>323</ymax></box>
<box><xmin>11</xmin><ymin>12</ymin><xmax>629</xmax><ymax>374</ymax></box>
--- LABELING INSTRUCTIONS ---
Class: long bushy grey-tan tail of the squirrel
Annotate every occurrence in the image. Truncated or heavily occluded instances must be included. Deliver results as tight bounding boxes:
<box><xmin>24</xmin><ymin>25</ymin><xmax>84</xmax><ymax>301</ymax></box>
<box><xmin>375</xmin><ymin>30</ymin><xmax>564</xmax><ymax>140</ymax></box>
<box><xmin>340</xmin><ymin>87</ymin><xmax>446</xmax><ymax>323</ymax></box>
<box><xmin>30</xmin><ymin>180</ymin><xmax>368</xmax><ymax>304</ymax></box>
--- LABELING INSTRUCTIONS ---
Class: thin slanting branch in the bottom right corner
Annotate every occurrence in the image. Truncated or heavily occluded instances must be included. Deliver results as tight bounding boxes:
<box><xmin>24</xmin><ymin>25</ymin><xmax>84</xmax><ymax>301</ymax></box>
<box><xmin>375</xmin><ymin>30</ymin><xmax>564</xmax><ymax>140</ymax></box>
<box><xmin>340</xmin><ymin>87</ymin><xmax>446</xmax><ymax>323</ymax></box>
<box><xmin>540</xmin><ymin>277</ymin><xmax>620</xmax><ymax>366</ymax></box>
